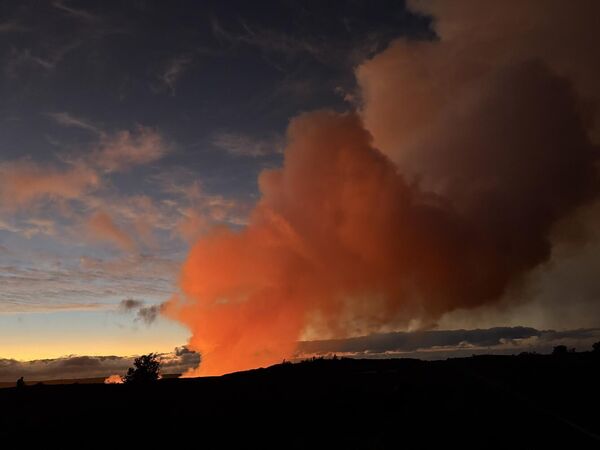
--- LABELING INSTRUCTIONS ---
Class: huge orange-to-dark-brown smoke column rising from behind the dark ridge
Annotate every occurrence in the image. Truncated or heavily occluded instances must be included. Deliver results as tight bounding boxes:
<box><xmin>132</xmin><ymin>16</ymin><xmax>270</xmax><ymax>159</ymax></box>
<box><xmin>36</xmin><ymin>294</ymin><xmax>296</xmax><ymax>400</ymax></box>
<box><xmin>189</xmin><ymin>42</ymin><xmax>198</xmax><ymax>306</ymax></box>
<box><xmin>165</xmin><ymin>2</ymin><xmax>600</xmax><ymax>375</ymax></box>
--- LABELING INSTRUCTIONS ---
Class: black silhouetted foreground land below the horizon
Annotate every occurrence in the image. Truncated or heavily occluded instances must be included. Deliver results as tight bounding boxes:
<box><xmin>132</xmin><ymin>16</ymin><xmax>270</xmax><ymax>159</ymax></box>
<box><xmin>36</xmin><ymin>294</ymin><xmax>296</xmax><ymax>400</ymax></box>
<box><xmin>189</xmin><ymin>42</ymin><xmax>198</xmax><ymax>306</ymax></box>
<box><xmin>0</xmin><ymin>353</ymin><xmax>600</xmax><ymax>449</ymax></box>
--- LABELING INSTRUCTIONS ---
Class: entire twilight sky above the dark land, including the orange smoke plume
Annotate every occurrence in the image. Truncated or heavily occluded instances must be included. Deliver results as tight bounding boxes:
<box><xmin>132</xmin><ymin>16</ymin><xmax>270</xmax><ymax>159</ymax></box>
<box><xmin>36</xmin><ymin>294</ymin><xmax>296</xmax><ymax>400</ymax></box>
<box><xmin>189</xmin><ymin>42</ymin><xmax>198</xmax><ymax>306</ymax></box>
<box><xmin>0</xmin><ymin>0</ymin><xmax>600</xmax><ymax>378</ymax></box>
